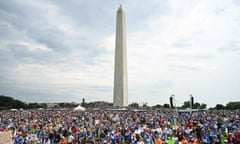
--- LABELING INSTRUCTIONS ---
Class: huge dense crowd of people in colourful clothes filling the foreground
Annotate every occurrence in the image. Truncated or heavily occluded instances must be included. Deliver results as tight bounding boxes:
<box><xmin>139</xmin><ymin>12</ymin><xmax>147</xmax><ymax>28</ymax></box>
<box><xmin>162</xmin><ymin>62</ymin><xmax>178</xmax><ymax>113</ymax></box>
<box><xmin>0</xmin><ymin>109</ymin><xmax>240</xmax><ymax>144</ymax></box>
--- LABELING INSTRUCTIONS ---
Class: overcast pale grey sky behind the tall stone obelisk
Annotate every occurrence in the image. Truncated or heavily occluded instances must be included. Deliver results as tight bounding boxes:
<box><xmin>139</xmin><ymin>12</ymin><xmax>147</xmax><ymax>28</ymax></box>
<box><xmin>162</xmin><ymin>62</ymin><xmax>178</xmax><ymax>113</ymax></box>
<box><xmin>0</xmin><ymin>0</ymin><xmax>240</xmax><ymax>107</ymax></box>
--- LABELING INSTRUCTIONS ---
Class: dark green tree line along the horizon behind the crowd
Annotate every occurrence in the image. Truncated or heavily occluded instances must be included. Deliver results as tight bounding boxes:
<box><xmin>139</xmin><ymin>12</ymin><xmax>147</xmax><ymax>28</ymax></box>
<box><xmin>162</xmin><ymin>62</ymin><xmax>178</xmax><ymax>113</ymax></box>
<box><xmin>0</xmin><ymin>95</ymin><xmax>240</xmax><ymax>110</ymax></box>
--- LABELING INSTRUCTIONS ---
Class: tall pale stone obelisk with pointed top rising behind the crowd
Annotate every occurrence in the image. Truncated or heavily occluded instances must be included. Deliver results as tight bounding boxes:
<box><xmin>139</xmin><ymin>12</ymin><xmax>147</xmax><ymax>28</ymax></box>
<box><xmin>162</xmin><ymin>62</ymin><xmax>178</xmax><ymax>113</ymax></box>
<box><xmin>113</xmin><ymin>5</ymin><xmax>128</xmax><ymax>107</ymax></box>
